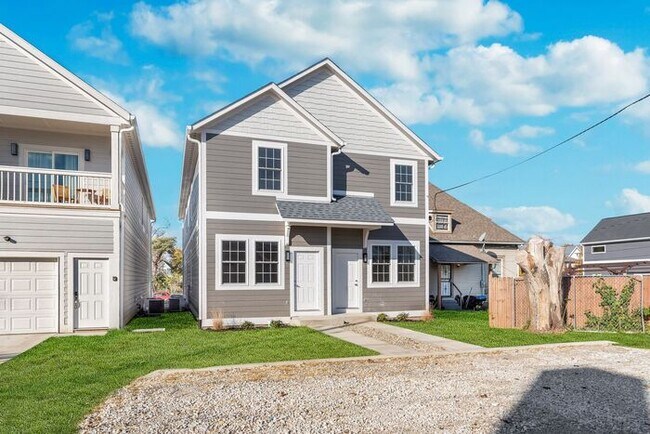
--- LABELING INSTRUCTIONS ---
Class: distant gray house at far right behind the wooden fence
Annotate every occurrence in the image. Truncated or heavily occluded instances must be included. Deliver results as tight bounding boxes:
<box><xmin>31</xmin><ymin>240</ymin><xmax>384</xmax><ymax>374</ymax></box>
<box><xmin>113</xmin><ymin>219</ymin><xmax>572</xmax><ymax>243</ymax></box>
<box><xmin>581</xmin><ymin>212</ymin><xmax>650</xmax><ymax>274</ymax></box>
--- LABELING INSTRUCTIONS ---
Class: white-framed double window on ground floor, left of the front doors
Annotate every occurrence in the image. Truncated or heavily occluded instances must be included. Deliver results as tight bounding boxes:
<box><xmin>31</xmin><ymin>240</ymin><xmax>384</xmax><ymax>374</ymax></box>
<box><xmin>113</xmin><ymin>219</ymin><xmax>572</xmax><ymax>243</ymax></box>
<box><xmin>215</xmin><ymin>234</ymin><xmax>285</xmax><ymax>290</ymax></box>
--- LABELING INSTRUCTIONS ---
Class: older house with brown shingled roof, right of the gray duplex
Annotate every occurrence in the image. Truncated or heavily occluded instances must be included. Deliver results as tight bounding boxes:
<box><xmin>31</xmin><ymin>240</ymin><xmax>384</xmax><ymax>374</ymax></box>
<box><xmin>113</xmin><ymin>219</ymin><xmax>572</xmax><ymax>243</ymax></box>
<box><xmin>429</xmin><ymin>184</ymin><xmax>524</xmax><ymax>309</ymax></box>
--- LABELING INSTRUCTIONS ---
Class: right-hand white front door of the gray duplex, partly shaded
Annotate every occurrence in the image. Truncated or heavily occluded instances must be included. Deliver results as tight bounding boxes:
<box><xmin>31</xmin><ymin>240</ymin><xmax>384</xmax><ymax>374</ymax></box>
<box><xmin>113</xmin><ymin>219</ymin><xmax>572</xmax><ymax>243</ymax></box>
<box><xmin>332</xmin><ymin>249</ymin><xmax>361</xmax><ymax>313</ymax></box>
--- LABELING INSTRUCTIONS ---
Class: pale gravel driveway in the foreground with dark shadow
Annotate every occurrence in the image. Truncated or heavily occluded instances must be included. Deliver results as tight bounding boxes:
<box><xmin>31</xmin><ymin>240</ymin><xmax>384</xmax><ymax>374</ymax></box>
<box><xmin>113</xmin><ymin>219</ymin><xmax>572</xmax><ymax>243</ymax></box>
<box><xmin>81</xmin><ymin>345</ymin><xmax>650</xmax><ymax>433</ymax></box>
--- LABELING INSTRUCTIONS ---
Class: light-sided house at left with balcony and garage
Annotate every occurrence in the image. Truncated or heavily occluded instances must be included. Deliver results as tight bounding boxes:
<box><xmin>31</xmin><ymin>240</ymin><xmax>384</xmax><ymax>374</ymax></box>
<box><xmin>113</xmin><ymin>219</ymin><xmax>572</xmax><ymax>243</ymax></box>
<box><xmin>0</xmin><ymin>25</ymin><xmax>155</xmax><ymax>334</ymax></box>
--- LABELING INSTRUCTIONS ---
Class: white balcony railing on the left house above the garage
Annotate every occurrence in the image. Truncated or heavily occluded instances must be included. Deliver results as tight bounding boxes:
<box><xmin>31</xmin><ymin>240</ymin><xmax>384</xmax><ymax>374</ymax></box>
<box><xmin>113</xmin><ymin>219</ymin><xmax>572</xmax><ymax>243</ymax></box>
<box><xmin>0</xmin><ymin>166</ymin><xmax>111</xmax><ymax>207</ymax></box>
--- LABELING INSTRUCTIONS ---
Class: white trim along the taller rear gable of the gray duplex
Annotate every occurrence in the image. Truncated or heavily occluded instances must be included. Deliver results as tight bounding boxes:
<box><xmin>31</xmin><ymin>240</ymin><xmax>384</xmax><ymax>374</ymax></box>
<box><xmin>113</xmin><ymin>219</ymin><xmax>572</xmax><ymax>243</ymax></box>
<box><xmin>279</xmin><ymin>59</ymin><xmax>442</xmax><ymax>162</ymax></box>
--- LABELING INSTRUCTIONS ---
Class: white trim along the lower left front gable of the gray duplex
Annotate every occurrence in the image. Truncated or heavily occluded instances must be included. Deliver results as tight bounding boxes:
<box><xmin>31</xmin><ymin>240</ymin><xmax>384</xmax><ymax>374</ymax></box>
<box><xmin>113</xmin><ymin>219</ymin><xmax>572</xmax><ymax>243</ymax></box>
<box><xmin>190</xmin><ymin>83</ymin><xmax>344</xmax><ymax>147</ymax></box>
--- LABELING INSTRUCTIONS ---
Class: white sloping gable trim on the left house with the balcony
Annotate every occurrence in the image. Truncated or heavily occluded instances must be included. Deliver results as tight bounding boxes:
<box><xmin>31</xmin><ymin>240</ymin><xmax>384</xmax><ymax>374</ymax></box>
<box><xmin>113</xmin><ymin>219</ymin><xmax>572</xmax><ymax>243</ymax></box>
<box><xmin>0</xmin><ymin>24</ymin><xmax>131</xmax><ymax>122</ymax></box>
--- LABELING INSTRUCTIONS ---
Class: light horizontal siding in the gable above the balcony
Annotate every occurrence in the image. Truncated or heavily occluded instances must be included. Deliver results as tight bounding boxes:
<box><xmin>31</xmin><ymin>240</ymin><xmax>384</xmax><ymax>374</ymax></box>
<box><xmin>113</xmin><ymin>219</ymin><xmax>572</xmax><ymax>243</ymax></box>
<box><xmin>0</xmin><ymin>35</ymin><xmax>106</xmax><ymax>116</ymax></box>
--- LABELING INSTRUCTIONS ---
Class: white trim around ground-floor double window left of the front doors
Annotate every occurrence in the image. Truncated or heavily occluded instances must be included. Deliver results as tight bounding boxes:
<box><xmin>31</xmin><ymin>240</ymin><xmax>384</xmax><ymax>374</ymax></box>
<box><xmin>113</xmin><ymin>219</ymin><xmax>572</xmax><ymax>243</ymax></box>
<box><xmin>214</xmin><ymin>234</ymin><xmax>286</xmax><ymax>291</ymax></box>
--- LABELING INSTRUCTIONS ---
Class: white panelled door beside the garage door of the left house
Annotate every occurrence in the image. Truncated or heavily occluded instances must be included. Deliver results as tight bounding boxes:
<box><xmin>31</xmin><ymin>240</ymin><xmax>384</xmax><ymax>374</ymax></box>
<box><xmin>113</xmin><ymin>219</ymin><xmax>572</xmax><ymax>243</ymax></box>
<box><xmin>75</xmin><ymin>259</ymin><xmax>108</xmax><ymax>329</ymax></box>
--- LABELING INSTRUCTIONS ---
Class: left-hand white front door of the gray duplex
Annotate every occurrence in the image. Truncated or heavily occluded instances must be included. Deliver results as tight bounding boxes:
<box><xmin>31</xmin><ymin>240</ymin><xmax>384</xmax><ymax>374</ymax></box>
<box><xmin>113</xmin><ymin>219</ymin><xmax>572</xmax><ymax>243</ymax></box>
<box><xmin>293</xmin><ymin>250</ymin><xmax>323</xmax><ymax>315</ymax></box>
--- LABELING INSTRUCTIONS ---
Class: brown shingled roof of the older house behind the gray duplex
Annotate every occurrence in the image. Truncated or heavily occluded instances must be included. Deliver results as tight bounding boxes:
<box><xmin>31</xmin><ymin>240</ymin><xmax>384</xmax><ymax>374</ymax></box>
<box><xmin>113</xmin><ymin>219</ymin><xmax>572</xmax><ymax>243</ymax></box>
<box><xmin>429</xmin><ymin>184</ymin><xmax>524</xmax><ymax>244</ymax></box>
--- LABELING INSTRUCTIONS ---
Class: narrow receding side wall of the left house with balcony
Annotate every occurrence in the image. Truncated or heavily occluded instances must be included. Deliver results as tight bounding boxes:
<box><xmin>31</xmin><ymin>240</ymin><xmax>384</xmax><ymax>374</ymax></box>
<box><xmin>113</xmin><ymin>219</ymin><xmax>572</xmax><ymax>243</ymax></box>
<box><xmin>122</xmin><ymin>147</ymin><xmax>151</xmax><ymax>324</ymax></box>
